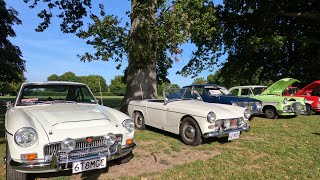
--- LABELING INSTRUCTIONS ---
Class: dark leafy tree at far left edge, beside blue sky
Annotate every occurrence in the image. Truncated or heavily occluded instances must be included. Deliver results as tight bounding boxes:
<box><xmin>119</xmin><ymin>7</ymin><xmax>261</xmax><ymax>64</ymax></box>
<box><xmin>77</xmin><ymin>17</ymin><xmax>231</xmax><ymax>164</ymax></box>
<box><xmin>0</xmin><ymin>0</ymin><xmax>25</xmax><ymax>85</ymax></box>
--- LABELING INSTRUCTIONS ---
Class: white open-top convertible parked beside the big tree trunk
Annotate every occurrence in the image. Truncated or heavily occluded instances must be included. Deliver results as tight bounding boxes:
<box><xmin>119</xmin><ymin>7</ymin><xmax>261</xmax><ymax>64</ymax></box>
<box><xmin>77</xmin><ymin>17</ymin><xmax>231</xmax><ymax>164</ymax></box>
<box><xmin>128</xmin><ymin>87</ymin><xmax>251</xmax><ymax>146</ymax></box>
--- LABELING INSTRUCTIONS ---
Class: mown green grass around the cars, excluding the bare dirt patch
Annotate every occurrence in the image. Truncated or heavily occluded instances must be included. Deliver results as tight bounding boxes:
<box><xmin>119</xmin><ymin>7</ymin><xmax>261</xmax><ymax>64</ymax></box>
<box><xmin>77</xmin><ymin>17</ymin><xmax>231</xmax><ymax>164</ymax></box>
<box><xmin>0</xmin><ymin>97</ymin><xmax>320</xmax><ymax>179</ymax></box>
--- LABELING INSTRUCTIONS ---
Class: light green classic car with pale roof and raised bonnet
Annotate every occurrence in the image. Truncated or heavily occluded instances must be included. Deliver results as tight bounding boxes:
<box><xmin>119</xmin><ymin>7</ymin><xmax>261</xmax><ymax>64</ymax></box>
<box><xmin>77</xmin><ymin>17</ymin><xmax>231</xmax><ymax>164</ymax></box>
<box><xmin>229</xmin><ymin>78</ymin><xmax>306</xmax><ymax>119</ymax></box>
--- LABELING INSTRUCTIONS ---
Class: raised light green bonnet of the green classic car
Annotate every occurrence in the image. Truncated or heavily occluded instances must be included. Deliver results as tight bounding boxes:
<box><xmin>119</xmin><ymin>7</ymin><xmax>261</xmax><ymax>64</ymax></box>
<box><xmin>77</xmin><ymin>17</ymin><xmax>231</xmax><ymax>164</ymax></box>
<box><xmin>261</xmin><ymin>78</ymin><xmax>299</xmax><ymax>95</ymax></box>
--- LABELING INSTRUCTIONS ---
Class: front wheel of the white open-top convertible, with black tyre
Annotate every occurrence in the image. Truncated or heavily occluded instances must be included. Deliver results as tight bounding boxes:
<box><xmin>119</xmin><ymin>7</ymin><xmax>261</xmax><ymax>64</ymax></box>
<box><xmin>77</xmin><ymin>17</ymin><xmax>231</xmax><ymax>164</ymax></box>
<box><xmin>180</xmin><ymin>117</ymin><xmax>202</xmax><ymax>146</ymax></box>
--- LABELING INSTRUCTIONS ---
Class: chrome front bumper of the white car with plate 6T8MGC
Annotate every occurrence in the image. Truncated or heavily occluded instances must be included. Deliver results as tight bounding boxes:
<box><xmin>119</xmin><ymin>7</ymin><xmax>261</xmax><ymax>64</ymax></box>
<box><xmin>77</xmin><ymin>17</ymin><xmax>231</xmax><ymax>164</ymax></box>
<box><xmin>10</xmin><ymin>143</ymin><xmax>136</xmax><ymax>173</ymax></box>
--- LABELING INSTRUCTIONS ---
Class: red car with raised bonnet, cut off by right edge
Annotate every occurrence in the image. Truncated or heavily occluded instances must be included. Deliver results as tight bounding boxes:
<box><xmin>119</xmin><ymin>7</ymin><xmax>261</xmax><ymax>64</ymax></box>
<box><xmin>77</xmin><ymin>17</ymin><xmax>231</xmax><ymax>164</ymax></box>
<box><xmin>291</xmin><ymin>80</ymin><xmax>320</xmax><ymax>115</ymax></box>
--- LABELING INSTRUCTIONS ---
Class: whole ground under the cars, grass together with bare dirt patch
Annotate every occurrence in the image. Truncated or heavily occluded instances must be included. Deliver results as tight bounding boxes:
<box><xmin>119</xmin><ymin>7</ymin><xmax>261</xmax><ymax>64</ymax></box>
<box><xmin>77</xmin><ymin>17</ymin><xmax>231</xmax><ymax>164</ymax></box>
<box><xmin>0</xmin><ymin>97</ymin><xmax>320</xmax><ymax>179</ymax></box>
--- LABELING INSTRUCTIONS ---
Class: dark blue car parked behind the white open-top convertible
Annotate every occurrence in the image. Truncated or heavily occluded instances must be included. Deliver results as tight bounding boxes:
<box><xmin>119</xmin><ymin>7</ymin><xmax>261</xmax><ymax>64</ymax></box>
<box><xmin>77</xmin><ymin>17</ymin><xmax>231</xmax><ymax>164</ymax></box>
<box><xmin>185</xmin><ymin>84</ymin><xmax>262</xmax><ymax>117</ymax></box>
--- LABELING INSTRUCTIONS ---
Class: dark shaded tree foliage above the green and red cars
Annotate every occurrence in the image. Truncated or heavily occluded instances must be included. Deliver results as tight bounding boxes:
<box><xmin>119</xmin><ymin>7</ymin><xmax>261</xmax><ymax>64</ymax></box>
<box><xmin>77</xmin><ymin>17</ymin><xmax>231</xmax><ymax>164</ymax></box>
<box><xmin>217</xmin><ymin>0</ymin><xmax>320</xmax><ymax>86</ymax></box>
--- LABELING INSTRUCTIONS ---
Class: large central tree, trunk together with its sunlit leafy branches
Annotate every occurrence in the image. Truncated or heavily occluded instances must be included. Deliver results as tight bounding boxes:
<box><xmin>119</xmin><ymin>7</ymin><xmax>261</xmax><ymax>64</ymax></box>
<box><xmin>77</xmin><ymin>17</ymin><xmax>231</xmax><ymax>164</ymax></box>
<box><xmin>25</xmin><ymin>0</ymin><xmax>221</xmax><ymax>111</ymax></box>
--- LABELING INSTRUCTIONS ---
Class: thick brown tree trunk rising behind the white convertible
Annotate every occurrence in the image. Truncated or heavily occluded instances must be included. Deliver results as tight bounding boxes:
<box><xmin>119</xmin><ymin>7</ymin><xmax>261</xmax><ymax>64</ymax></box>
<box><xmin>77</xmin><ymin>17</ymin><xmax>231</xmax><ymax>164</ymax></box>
<box><xmin>120</xmin><ymin>0</ymin><xmax>157</xmax><ymax>113</ymax></box>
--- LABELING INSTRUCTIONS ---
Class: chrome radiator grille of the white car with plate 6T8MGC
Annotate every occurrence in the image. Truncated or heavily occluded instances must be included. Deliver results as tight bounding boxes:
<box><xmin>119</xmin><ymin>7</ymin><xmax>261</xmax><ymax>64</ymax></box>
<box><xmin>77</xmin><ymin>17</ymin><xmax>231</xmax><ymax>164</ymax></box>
<box><xmin>44</xmin><ymin>134</ymin><xmax>122</xmax><ymax>161</ymax></box>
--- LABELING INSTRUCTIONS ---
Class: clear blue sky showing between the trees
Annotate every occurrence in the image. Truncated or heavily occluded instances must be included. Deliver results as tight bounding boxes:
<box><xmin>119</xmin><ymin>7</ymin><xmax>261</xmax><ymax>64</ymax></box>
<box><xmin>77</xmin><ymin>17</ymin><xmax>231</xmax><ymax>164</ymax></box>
<box><xmin>6</xmin><ymin>0</ymin><xmax>221</xmax><ymax>86</ymax></box>
